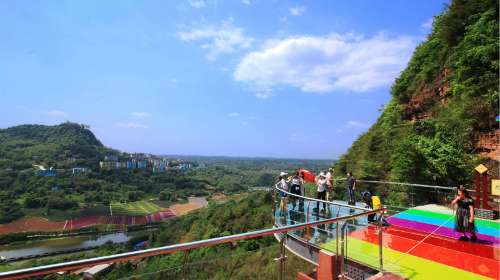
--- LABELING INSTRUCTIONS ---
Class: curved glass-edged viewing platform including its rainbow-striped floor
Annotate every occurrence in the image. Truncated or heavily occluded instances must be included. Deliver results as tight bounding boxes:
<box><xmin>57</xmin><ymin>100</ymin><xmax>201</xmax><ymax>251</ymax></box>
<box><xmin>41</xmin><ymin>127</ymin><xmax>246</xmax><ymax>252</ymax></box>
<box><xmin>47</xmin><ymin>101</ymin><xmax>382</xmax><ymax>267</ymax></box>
<box><xmin>274</xmin><ymin>182</ymin><xmax>500</xmax><ymax>280</ymax></box>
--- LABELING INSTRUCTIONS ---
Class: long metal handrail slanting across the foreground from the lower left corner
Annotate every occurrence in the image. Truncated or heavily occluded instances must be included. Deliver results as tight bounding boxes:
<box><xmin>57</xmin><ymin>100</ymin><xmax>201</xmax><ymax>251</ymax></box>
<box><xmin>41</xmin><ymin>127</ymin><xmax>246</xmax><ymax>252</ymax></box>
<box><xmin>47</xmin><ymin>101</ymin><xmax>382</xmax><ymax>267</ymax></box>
<box><xmin>0</xmin><ymin>208</ymin><xmax>385</xmax><ymax>280</ymax></box>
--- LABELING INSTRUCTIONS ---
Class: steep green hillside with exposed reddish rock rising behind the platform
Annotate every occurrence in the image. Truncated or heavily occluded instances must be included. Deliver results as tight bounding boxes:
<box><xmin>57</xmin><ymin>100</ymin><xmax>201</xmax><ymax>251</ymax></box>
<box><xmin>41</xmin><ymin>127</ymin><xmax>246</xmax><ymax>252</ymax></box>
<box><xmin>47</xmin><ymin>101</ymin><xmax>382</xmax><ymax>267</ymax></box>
<box><xmin>335</xmin><ymin>0</ymin><xmax>499</xmax><ymax>185</ymax></box>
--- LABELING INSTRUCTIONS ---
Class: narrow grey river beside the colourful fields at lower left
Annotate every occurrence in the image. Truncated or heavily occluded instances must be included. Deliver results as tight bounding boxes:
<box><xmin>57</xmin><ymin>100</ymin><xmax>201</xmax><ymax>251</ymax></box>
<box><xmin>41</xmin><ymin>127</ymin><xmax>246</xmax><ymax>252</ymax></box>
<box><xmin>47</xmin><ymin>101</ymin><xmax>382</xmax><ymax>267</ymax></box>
<box><xmin>0</xmin><ymin>230</ymin><xmax>151</xmax><ymax>259</ymax></box>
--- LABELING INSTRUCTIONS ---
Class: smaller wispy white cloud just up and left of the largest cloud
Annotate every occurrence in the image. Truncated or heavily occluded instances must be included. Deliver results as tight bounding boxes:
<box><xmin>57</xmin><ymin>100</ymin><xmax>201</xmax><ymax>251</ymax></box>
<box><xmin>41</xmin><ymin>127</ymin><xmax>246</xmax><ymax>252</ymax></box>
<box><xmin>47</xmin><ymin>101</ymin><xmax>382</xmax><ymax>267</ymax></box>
<box><xmin>177</xmin><ymin>18</ymin><xmax>253</xmax><ymax>61</ymax></box>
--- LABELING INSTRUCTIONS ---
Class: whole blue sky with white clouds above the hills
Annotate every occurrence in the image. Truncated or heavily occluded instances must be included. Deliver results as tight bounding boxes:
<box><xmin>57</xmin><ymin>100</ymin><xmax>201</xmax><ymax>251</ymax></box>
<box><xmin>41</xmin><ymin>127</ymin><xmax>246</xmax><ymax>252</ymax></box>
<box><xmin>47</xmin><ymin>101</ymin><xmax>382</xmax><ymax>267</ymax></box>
<box><xmin>0</xmin><ymin>0</ymin><xmax>446</xmax><ymax>159</ymax></box>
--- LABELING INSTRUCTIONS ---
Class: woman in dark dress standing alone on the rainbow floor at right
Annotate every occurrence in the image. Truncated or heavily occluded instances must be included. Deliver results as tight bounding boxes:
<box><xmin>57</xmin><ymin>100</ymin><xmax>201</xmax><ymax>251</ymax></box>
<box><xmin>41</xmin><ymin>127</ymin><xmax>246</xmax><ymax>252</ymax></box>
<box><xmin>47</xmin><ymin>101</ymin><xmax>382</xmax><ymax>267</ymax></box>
<box><xmin>451</xmin><ymin>186</ymin><xmax>477</xmax><ymax>241</ymax></box>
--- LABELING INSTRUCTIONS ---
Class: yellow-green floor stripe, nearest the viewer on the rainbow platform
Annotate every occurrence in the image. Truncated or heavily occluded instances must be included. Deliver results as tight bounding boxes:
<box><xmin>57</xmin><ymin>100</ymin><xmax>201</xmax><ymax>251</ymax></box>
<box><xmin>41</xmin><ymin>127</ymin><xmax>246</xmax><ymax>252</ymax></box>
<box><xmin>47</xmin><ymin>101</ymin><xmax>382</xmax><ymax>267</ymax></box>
<box><xmin>321</xmin><ymin>238</ymin><xmax>490</xmax><ymax>280</ymax></box>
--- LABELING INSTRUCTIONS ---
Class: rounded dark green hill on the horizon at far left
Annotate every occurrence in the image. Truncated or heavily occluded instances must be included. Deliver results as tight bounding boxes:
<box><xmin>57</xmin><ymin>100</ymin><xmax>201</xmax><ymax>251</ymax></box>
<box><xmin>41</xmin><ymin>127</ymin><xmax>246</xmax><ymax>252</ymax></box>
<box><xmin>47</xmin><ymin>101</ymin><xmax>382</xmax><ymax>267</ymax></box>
<box><xmin>0</xmin><ymin>122</ymin><xmax>117</xmax><ymax>169</ymax></box>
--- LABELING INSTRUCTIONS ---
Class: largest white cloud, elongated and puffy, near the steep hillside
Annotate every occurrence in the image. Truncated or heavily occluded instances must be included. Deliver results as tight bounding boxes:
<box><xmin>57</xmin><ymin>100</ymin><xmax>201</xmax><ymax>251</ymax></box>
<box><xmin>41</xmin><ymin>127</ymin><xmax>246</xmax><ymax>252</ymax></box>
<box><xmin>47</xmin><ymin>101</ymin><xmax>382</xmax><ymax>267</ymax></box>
<box><xmin>233</xmin><ymin>33</ymin><xmax>416</xmax><ymax>95</ymax></box>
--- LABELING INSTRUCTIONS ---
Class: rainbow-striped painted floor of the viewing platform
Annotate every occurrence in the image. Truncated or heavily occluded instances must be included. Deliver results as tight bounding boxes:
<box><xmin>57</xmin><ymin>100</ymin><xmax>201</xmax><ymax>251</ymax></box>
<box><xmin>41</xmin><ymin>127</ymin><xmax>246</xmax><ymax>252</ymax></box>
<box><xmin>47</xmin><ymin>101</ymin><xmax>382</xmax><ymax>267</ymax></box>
<box><xmin>321</xmin><ymin>206</ymin><xmax>500</xmax><ymax>280</ymax></box>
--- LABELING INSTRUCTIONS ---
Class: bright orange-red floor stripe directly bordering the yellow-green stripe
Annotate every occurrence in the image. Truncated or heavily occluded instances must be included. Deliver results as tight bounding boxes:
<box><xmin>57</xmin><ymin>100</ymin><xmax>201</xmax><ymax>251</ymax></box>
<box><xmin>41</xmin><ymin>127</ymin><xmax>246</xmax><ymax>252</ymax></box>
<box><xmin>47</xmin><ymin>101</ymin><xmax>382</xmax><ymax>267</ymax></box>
<box><xmin>350</xmin><ymin>227</ymin><xmax>500</xmax><ymax>279</ymax></box>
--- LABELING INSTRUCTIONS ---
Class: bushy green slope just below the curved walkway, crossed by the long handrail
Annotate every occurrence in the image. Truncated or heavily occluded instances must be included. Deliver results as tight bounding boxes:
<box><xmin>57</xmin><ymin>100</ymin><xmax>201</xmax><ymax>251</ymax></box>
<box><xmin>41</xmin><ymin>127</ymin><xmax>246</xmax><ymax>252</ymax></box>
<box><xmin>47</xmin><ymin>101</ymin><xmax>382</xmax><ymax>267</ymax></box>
<box><xmin>101</xmin><ymin>193</ymin><xmax>312</xmax><ymax>279</ymax></box>
